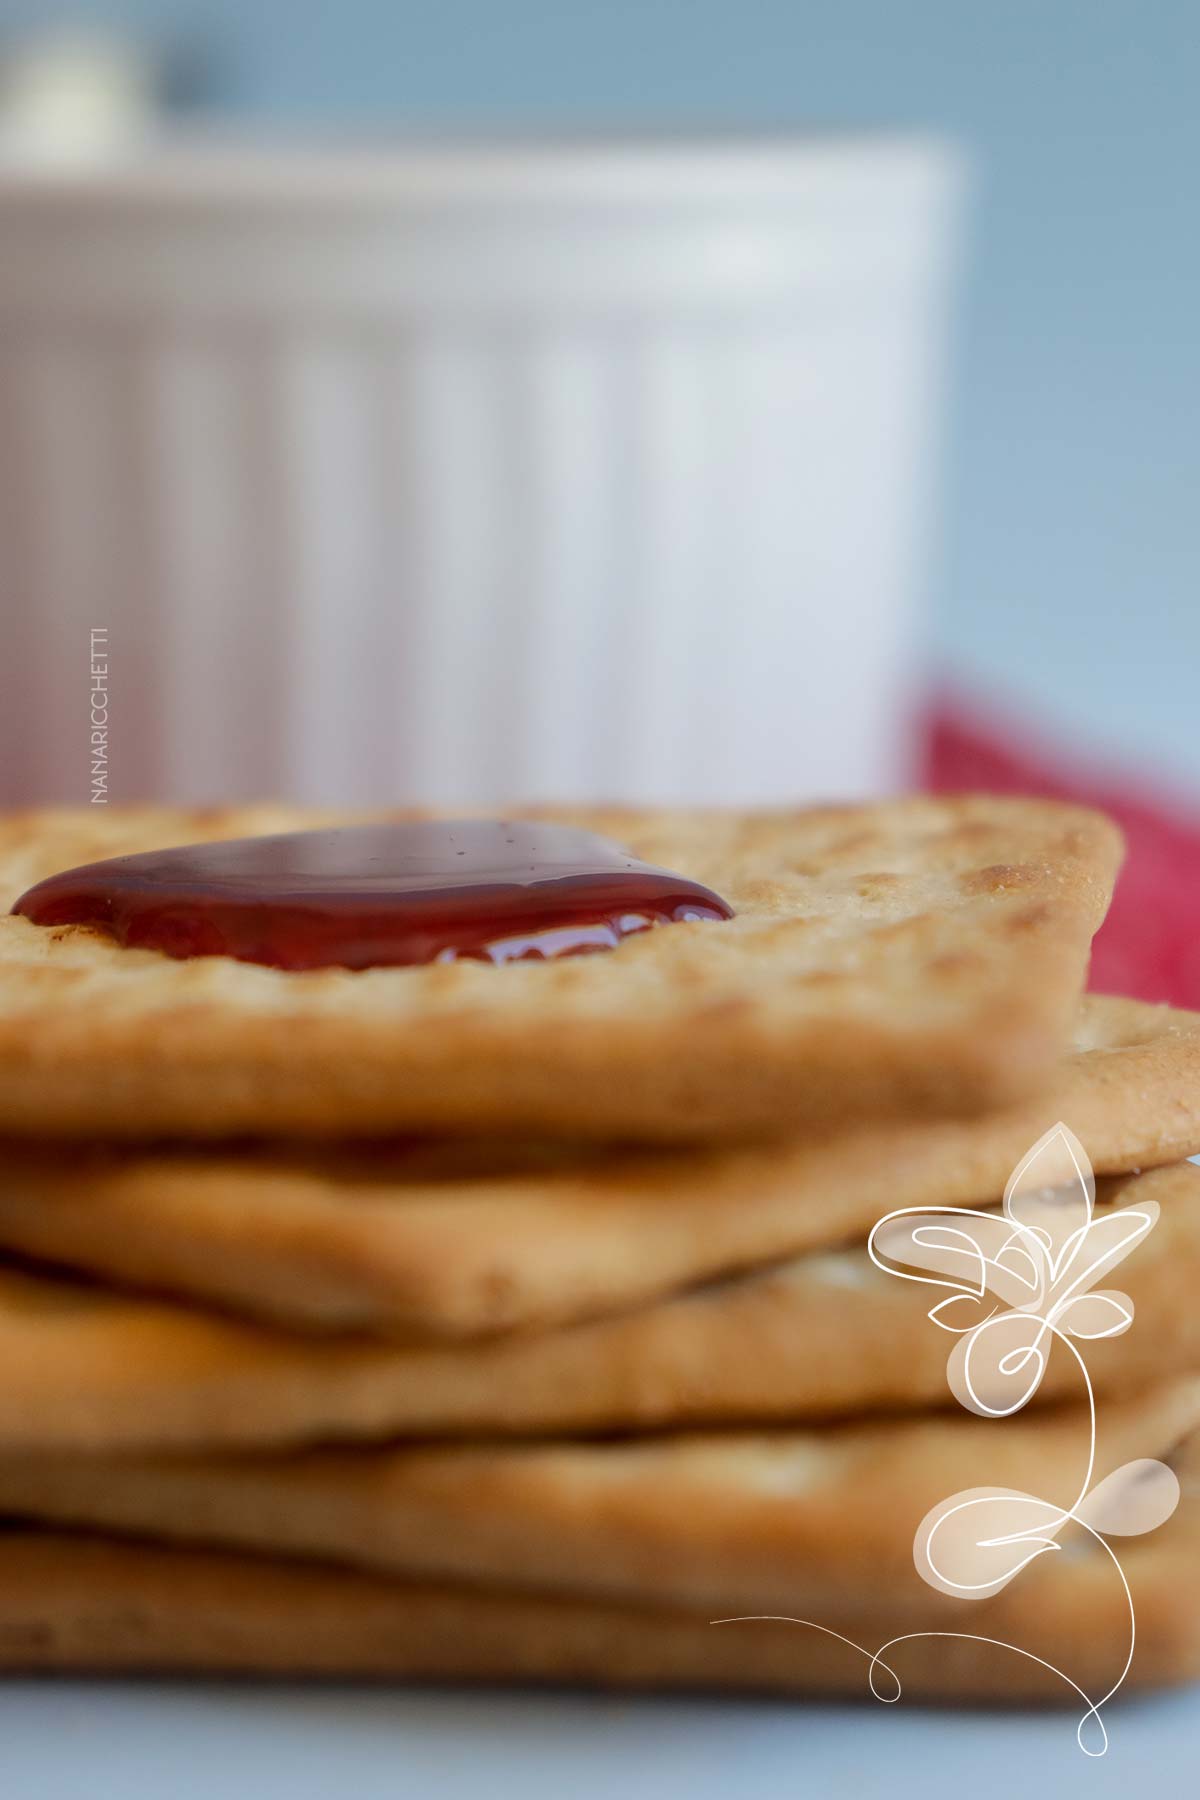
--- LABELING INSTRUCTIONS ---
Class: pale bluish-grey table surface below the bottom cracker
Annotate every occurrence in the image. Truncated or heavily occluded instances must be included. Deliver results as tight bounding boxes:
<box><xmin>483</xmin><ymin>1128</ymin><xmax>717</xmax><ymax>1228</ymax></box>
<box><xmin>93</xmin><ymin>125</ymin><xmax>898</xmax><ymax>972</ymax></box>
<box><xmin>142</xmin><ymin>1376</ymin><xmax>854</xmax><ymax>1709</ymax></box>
<box><xmin>0</xmin><ymin>1681</ymin><xmax>1200</xmax><ymax>1800</ymax></box>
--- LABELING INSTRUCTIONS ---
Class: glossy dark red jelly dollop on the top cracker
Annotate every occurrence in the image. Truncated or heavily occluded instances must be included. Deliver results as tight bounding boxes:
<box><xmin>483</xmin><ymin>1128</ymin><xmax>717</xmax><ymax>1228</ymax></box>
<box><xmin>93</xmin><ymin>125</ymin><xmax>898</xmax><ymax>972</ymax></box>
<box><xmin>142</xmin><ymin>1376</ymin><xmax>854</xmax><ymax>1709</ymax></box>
<box><xmin>13</xmin><ymin>819</ymin><xmax>732</xmax><ymax>968</ymax></box>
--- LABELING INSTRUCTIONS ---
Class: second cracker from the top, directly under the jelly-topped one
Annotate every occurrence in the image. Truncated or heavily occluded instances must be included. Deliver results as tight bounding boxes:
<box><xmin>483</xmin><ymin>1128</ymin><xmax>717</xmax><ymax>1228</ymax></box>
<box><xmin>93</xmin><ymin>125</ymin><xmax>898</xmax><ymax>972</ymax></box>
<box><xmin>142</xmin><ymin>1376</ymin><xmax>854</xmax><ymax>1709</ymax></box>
<box><xmin>0</xmin><ymin>997</ymin><xmax>1200</xmax><ymax>1337</ymax></box>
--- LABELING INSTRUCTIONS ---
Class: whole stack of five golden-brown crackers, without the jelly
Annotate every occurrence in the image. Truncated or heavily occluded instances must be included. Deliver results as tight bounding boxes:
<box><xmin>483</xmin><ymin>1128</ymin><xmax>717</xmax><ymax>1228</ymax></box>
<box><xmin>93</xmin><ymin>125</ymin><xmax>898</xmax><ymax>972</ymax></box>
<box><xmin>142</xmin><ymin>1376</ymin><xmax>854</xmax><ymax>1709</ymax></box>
<box><xmin>0</xmin><ymin>799</ymin><xmax>1200</xmax><ymax>1701</ymax></box>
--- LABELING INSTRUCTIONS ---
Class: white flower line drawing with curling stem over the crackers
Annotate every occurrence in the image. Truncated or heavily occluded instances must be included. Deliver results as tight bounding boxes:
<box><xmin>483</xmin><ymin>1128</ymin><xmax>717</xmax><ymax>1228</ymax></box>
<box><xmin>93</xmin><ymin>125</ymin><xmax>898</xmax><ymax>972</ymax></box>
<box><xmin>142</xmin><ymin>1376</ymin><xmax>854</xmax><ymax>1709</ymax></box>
<box><xmin>712</xmin><ymin>1121</ymin><xmax>1180</xmax><ymax>1757</ymax></box>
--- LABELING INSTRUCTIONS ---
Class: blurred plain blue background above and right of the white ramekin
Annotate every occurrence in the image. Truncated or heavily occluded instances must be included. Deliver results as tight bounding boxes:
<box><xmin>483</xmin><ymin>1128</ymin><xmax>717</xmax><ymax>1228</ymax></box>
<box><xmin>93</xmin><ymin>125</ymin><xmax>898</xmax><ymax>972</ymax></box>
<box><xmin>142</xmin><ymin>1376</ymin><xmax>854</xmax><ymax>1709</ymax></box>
<box><xmin>0</xmin><ymin>0</ymin><xmax>1200</xmax><ymax>779</ymax></box>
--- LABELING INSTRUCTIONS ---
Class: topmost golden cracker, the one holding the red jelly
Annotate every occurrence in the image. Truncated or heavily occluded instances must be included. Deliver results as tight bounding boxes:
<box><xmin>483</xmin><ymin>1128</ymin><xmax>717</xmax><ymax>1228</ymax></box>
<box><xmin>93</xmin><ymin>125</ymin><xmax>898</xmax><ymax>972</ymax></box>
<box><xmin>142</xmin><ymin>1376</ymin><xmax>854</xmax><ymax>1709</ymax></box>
<box><xmin>0</xmin><ymin>797</ymin><xmax>1121</xmax><ymax>1139</ymax></box>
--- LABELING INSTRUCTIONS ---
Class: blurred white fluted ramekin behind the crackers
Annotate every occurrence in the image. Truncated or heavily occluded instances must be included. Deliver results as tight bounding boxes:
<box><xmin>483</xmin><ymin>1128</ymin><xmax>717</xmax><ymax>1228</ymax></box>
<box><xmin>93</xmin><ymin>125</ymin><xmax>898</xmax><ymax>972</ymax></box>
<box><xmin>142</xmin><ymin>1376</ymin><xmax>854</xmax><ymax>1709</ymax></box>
<box><xmin>0</xmin><ymin>139</ymin><xmax>959</xmax><ymax>803</ymax></box>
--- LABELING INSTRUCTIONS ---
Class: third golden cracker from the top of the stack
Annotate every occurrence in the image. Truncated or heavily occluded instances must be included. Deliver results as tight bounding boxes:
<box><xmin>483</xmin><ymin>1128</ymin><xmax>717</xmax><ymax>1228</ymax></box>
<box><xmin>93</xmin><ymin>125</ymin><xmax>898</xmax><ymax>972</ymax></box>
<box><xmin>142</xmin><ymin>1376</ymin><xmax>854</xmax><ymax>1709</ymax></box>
<box><xmin>0</xmin><ymin>1163</ymin><xmax>1200</xmax><ymax>1456</ymax></box>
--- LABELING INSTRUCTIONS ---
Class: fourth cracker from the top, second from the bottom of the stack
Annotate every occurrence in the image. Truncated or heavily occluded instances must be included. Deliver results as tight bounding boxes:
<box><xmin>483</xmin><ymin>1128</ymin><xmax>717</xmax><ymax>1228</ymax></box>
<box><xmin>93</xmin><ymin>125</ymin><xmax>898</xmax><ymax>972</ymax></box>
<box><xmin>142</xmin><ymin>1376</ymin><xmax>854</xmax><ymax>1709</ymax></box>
<box><xmin>0</xmin><ymin>1377</ymin><xmax>1200</xmax><ymax>1631</ymax></box>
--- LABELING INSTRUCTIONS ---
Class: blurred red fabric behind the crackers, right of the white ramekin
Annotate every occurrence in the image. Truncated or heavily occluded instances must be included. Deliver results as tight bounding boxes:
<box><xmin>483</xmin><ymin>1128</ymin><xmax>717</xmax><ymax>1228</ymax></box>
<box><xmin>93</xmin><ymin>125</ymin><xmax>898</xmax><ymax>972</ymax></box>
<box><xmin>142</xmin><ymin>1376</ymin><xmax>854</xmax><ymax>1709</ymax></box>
<box><xmin>925</xmin><ymin>700</ymin><xmax>1200</xmax><ymax>1008</ymax></box>
